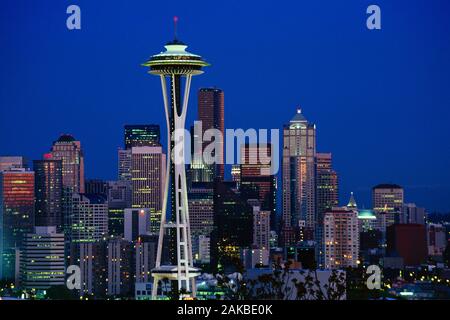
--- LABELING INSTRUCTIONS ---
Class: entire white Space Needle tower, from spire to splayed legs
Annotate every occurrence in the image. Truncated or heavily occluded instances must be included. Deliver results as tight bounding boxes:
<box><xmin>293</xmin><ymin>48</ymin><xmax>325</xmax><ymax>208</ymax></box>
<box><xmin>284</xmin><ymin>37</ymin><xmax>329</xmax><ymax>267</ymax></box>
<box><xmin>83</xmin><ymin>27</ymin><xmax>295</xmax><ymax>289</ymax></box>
<box><xmin>143</xmin><ymin>17</ymin><xmax>209</xmax><ymax>299</ymax></box>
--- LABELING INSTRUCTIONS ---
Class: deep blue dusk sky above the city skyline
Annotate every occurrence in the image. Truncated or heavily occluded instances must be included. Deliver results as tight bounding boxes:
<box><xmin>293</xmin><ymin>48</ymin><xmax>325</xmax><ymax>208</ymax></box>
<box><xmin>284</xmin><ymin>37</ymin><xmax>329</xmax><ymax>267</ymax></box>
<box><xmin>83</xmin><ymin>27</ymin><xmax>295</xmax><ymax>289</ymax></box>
<box><xmin>0</xmin><ymin>0</ymin><xmax>450</xmax><ymax>211</ymax></box>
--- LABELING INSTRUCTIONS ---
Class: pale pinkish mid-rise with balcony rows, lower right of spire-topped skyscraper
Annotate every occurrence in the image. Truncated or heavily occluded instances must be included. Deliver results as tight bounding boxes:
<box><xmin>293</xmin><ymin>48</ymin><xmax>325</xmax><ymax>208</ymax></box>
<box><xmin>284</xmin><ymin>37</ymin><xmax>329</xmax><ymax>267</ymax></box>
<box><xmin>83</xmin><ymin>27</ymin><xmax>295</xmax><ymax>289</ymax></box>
<box><xmin>323</xmin><ymin>207</ymin><xmax>359</xmax><ymax>269</ymax></box>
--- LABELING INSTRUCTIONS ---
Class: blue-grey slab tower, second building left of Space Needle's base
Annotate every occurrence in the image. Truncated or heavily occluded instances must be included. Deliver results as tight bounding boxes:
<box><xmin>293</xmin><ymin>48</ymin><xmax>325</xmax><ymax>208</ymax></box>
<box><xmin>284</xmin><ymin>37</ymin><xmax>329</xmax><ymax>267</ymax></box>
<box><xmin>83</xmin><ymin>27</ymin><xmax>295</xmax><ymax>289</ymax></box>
<box><xmin>107</xmin><ymin>239</ymin><xmax>134</xmax><ymax>296</ymax></box>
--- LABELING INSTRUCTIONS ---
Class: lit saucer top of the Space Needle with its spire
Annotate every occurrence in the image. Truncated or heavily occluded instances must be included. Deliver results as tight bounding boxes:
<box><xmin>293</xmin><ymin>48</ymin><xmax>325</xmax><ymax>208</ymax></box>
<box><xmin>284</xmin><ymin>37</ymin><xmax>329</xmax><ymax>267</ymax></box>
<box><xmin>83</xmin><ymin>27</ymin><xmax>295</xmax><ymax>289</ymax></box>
<box><xmin>143</xmin><ymin>17</ymin><xmax>209</xmax><ymax>75</ymax></box>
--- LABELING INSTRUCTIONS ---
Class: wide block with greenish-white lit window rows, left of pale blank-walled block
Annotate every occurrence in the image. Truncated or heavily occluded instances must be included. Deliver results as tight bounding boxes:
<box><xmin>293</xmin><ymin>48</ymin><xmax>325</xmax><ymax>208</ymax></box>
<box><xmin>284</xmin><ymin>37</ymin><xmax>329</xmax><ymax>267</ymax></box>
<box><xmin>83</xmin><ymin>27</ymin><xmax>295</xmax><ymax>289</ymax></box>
<box><xmin>69</xmin><ymin>193</ymin><xmax>108</xmax><ymax>243</ymax></box>
